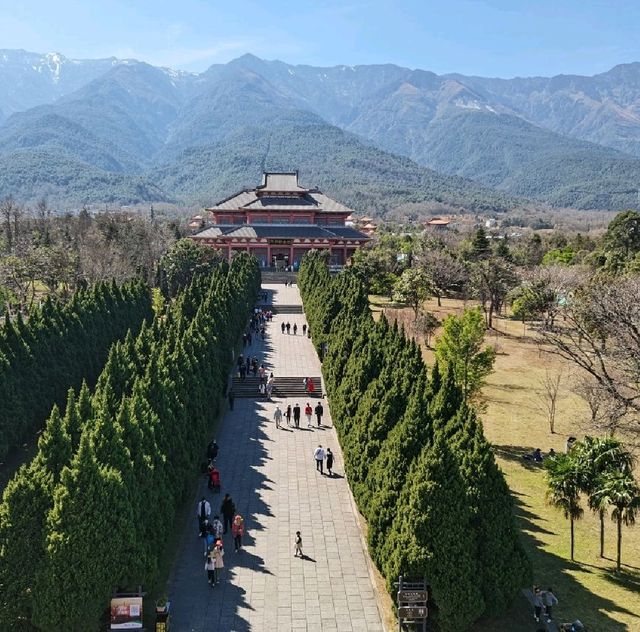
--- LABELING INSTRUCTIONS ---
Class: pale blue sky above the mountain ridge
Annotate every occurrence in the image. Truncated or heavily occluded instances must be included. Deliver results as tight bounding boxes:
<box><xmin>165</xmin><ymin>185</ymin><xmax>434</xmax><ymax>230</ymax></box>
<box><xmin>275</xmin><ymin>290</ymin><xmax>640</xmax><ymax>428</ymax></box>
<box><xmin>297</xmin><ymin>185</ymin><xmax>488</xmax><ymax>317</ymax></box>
<box><xmin>0</xmin><ymin>0</ymin><xmax>640</xmax><ymax>77</ymax></box>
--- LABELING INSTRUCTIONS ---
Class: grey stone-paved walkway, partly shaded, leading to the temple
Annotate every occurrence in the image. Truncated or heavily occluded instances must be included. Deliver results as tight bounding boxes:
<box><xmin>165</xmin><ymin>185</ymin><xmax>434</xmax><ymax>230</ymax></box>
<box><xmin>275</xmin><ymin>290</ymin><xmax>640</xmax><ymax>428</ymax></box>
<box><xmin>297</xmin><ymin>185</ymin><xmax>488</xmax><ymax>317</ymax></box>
<box><xmin>170</xmin><ymin>285</ymin><xmax>383</xmax><ymax>632</ymax></box>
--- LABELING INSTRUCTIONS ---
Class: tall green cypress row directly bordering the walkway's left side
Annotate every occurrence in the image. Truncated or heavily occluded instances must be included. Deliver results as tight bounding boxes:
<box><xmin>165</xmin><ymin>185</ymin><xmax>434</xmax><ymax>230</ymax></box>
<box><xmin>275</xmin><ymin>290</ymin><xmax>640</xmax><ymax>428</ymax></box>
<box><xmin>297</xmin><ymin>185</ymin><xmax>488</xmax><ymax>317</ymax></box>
<box><xmin>0</xmin><ymin>255</ymin><xmax>260</xmax><ymax>632</ymax></box>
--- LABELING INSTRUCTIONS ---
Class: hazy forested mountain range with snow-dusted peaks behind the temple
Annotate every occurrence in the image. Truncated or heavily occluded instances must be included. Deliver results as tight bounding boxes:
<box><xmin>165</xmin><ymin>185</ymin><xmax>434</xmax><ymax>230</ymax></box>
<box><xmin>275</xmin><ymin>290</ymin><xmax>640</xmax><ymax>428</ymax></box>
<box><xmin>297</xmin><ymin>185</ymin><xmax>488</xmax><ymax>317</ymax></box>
<box><xmin>0</xmin><ymin>50</ymin><xmax>640</xmax><ymax>216</ymax></box>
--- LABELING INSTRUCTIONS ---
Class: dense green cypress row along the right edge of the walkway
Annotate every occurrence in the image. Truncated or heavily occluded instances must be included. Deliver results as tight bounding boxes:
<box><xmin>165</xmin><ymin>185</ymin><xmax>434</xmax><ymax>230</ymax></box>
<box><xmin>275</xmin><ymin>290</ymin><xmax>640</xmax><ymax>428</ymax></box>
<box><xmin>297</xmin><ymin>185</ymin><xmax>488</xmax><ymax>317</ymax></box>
<box><xmin>298</xmin><ymin>253</ymin><xmax>530</xmax><ymax>632</ymax></box>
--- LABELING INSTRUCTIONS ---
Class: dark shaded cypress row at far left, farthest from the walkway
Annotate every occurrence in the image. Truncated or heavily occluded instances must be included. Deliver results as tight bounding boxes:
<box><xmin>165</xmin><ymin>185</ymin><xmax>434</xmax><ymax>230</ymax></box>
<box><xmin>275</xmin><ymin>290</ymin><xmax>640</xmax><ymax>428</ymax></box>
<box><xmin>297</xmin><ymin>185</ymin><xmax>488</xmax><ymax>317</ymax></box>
<box><xmin>0</xmin><ymin>281</ymin><xmax>152</xmax><ymax>460</ymax></box>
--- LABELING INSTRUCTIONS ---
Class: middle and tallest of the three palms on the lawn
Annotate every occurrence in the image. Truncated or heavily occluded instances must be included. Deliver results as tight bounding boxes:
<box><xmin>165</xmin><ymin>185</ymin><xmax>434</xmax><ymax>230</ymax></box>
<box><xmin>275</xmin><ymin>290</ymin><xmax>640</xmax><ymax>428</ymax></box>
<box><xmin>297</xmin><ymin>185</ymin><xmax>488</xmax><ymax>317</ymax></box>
<box><xmin>572</xmin><ymin>436</ymin><xmax>635</xmax><ymax>557</ymax></box>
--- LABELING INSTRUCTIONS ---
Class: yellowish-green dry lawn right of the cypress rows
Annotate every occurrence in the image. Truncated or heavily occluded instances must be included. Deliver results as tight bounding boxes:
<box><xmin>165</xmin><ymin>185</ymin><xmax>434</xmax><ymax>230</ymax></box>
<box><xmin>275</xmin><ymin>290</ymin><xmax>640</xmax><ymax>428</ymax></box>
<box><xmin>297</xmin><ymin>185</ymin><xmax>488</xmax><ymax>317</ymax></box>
<box><xmin>372</xmin><ymin>297</ymin><xmax>640</xmax><ymax>632</ymax></box>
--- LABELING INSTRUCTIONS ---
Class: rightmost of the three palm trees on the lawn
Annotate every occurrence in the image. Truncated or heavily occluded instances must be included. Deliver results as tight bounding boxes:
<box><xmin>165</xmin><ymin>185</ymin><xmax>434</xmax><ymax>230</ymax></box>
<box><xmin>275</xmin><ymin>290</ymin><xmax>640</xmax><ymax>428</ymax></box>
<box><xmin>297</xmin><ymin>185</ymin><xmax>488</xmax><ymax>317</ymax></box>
<box><xmin>593</xmin><ymin>471</ymin><xmax>640</xmax><ymax>573</ymax></box>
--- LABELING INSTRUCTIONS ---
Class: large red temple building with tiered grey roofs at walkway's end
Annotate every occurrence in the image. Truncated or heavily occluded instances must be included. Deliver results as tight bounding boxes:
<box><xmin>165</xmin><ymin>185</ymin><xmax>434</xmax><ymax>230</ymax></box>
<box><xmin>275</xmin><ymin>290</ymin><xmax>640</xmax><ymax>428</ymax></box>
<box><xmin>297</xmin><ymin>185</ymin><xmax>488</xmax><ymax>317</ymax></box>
<box><xmin>191</xmin><ymin>171</ymin><xmax>370</xmax><ymax>268</ymax></box>
